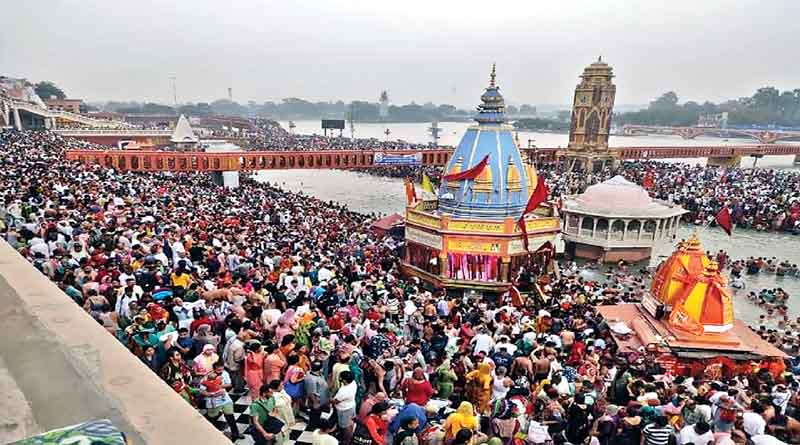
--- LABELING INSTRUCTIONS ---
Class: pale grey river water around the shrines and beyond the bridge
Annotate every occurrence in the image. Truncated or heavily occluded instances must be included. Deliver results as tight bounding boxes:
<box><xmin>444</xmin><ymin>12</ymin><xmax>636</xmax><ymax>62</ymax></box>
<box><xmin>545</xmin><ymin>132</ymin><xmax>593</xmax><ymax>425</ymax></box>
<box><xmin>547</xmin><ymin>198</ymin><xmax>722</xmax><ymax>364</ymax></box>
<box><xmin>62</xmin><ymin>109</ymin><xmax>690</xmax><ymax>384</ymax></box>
<box><xmin>256</xmin><ymin>121</ymin><xmax>800</xmax><ymax>324</ymax></box>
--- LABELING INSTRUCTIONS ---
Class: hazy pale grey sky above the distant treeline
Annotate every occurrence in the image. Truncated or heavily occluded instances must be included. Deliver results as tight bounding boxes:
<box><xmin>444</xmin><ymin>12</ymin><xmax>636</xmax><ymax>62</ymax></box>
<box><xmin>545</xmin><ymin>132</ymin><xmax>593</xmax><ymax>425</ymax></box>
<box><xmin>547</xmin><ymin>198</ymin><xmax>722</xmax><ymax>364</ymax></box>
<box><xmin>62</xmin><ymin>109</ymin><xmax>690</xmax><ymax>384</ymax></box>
<box><xmin>0</xmin><ymin>0</ymin><xmax>800</xmax><ymax>106</ymax></box>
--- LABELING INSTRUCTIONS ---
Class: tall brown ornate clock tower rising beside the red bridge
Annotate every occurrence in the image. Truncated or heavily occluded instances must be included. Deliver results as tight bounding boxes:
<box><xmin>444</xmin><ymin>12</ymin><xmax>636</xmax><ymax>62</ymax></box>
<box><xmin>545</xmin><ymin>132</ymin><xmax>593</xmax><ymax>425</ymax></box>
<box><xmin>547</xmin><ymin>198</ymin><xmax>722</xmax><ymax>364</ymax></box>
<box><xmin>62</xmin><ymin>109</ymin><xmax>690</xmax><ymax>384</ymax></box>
<box><xmin>566</xmin><ymin>58</ymin><xmax>617</xmax><ymax>172</ymax></box>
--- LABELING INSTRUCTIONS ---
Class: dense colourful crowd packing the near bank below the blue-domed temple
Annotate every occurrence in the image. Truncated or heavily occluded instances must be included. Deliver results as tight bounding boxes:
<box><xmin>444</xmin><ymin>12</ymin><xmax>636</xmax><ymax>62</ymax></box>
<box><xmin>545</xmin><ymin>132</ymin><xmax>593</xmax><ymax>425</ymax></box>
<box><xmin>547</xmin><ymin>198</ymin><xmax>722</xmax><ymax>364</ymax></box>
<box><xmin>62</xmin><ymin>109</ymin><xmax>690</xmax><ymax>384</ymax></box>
<box><xmin>0</xmin><ymin>127</ymin><xmax>800</xmax><ymax>445</ymax></box>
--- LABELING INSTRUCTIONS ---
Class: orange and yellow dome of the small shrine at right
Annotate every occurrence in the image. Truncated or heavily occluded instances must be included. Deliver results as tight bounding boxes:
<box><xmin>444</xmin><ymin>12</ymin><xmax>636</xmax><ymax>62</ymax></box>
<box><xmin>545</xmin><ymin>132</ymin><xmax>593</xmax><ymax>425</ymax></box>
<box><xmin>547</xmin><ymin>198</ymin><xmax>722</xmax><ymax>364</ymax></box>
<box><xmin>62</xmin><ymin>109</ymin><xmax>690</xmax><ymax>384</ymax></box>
<box><xmin>650</xmin><ymin>235</ymin><xmax>733</xmax><ymax>335</ymax></box>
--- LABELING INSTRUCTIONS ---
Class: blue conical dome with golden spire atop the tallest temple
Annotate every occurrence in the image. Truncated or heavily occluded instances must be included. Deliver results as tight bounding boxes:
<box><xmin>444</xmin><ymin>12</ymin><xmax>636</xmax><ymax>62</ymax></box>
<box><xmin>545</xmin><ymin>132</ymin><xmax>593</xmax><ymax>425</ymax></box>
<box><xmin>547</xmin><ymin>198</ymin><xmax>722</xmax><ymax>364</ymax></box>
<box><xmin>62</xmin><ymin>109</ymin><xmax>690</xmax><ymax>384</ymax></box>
<box><xmin>439</xmin><ymin>67</ymin><xmax>537</xmax><ymax>219</ymax></box>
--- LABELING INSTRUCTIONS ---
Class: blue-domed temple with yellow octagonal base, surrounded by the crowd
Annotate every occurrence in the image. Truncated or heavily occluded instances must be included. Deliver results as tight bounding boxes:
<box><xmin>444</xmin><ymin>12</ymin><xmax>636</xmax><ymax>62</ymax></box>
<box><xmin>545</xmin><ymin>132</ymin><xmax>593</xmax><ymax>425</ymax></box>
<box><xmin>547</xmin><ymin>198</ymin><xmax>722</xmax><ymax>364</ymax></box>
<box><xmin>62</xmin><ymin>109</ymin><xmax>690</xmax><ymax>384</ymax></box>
<box><xmin>403</xmin><ymin>67</ymin><xmax>560</xmax><ymax>293</ymax></box>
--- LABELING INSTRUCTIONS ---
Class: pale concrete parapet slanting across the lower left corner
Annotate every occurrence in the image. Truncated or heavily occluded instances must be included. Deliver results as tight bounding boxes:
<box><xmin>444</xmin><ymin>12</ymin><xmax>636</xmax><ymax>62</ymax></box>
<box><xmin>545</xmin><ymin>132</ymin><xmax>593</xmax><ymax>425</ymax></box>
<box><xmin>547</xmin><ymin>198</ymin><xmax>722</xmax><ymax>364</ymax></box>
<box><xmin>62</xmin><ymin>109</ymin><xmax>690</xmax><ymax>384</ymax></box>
<box><xmin>0</xmin><ymin>242</ymin><xmax>230</xmax><ymax>445</ymax></box>
